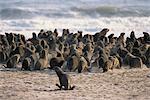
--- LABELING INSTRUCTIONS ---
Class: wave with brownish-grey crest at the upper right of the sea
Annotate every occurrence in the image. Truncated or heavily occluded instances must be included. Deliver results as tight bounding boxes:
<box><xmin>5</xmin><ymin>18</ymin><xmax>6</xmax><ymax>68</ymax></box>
<box><xmin>71</xmin><ymin>5</ymin><xmax>150</xmax><ymax>17</ymax></box>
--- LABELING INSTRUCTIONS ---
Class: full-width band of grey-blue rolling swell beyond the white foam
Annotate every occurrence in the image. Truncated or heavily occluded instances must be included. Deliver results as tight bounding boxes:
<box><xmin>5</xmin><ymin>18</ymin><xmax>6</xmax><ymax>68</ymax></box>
<box><xmin>0</xmin><ymin>0</ymin><xmax>150</xmax><ymax>20</ymax></box>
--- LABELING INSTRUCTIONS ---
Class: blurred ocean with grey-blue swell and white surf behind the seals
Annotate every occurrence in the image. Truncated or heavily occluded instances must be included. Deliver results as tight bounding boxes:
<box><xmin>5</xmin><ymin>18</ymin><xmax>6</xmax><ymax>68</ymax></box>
<box><xmin>0</xmin><ymin>0</ymin><xmax>150</xmax><ymax>38</ymax></box>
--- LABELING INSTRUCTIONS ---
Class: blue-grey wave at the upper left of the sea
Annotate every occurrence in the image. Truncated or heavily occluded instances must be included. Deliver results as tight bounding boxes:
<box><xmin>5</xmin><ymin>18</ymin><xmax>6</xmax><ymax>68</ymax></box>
<box><xmin>0</xmin><ymin>8</ymin><xmax>74</xmax><ymax>20</ymax></box>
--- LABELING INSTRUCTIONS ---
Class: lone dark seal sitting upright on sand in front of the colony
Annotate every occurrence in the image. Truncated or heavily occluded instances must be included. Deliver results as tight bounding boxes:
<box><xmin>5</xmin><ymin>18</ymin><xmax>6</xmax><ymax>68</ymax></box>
<box><xmin>54</xmin><ymin>66</ymin><xmax>75</xmax><ymax>90</ymax></box>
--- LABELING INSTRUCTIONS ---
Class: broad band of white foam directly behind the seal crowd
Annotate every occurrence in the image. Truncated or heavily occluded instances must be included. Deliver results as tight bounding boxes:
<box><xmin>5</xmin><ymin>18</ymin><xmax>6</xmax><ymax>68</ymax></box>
<box><xmin>0</xmin><ymin>17</ymin><xmax>150</xmax><ymax>38</ymax></box>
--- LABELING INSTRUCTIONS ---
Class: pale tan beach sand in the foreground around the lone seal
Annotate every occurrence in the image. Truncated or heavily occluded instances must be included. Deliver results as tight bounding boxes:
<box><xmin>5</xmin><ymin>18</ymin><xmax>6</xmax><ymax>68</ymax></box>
<box><xmin>0</xmin><ymin>65</ymin><xmax>150</xmax><ymax>100</ymax></box>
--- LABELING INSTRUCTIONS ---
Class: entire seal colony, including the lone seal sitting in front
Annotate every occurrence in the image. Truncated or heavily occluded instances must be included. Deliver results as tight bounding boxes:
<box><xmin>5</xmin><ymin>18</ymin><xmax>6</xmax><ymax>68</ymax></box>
<box><xmin>0</xmin><ymin>28</ymin><xmax>150</xmax><ymax>90</ymax></box>
